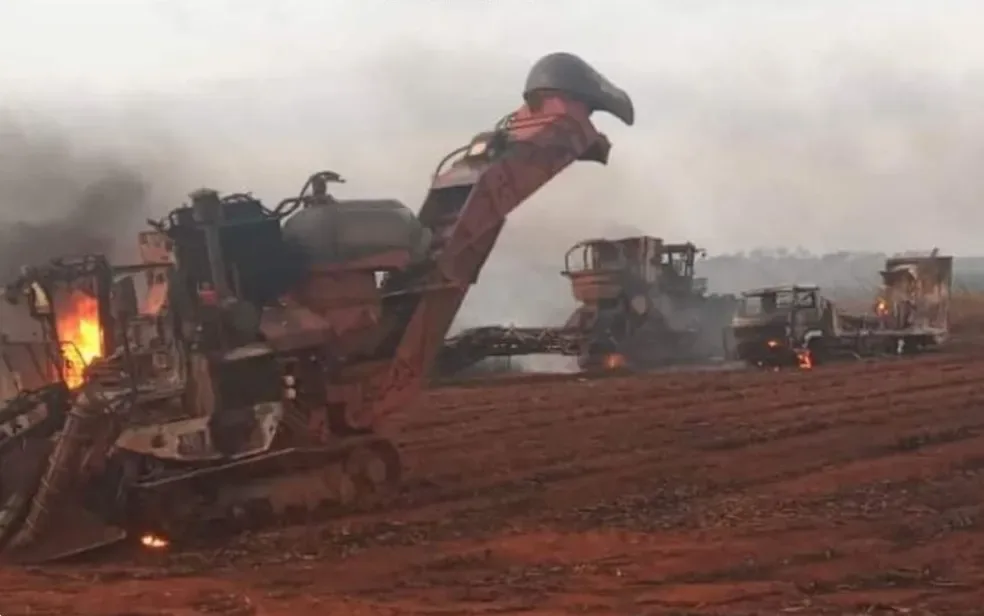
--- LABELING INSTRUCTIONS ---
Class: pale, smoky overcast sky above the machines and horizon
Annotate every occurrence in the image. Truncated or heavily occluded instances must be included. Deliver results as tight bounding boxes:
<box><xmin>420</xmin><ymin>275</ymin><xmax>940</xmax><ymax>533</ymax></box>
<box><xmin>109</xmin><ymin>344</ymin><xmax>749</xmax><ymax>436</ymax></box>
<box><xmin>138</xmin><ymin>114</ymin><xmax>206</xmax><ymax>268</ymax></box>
<box><xmin>0</xmin><ymin>0</ymin><xmax>984</xmax><ymax>264</ymax></box>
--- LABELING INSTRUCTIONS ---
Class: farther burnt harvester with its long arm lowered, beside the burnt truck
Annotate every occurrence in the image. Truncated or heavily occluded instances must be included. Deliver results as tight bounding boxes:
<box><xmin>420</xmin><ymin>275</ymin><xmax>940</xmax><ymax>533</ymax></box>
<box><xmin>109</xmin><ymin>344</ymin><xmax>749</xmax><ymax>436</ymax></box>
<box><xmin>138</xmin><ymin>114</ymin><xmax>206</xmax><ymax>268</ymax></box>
<box><xmin>438</xmin><ymin>236</ymin><xmax>737</xmax><ymax>374</ymax></box>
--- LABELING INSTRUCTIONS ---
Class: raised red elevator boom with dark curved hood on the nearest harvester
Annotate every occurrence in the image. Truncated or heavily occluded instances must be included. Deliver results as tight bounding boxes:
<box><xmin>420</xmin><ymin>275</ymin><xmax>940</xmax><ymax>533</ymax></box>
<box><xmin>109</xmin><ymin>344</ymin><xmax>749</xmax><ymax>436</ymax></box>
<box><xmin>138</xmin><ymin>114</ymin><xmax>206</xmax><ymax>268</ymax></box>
<box><xmin>345</xmin><ymin>53</ymin><xmax>635</xmax><ymax>428</ymax></box>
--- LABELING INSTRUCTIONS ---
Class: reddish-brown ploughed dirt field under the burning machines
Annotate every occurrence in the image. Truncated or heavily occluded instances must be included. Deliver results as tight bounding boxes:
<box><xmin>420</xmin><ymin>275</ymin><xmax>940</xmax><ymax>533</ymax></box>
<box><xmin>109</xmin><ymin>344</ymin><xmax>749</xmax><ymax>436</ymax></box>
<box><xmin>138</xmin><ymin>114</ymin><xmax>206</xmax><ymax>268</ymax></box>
<box><xmin>0</xmin><ymin>351</ymin><xmax>984</xmax><ymax>616</ymax></box>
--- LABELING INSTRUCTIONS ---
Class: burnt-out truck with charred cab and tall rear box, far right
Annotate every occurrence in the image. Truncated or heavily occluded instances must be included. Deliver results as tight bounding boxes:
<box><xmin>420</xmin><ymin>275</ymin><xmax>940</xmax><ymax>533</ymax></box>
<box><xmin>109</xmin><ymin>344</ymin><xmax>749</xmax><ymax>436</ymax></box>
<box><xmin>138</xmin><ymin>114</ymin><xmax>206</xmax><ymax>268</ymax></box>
<box><xmin>725</xmin><ymin>251</ymin><xmax>953</xmax><ymax>368</ymax></box>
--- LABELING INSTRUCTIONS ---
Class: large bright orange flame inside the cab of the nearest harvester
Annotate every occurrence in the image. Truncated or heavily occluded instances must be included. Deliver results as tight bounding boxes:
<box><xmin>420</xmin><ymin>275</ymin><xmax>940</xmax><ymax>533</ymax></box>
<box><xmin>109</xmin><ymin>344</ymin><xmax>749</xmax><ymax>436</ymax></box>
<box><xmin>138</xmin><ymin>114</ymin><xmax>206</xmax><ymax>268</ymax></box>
<box><xmin>55</xmin><ymin>291</ymin><xmax>103</xmax><ymax>389</ymax></box>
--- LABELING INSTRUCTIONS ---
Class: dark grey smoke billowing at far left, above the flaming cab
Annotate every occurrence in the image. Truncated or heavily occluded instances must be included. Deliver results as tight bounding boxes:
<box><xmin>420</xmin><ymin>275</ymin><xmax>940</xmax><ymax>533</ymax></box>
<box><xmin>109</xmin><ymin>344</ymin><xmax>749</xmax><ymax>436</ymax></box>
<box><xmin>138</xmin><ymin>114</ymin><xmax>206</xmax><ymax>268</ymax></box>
<box><xmin>0</xmin><ymin>117</ymin><xmax>190</xmax><ymax>281</ymax></box>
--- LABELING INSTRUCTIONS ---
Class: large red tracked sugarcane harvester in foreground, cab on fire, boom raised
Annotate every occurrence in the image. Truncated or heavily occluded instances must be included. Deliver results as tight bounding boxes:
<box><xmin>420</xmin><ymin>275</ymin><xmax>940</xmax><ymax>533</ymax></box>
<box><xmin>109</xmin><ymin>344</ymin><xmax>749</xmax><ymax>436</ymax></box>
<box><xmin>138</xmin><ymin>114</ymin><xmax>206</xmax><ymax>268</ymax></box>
<box><xmin>0</xmin><ymin>53</ymin><xmax>634</xmax><ymax>562</ymax></box>
